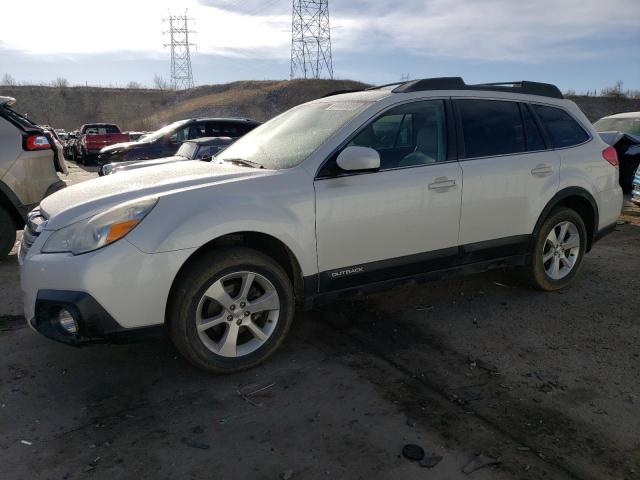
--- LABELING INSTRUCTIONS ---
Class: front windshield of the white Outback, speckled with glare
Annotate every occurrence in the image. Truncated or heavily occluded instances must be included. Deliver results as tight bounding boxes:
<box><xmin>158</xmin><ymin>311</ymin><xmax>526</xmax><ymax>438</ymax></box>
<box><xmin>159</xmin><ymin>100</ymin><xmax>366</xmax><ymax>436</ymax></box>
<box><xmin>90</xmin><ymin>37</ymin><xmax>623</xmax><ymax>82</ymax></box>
<box><xmin>216</xmin><ymin>99</ymin><xmax>369</xmax><ymax>170</ymax></box>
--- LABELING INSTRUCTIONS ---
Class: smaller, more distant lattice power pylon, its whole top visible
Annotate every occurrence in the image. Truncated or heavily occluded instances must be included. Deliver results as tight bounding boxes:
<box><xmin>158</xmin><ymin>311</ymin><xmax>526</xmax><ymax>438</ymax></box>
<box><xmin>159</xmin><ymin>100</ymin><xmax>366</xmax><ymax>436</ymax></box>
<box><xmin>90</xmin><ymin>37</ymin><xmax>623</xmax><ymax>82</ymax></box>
<box><xmin>162</xmin><ymin>10</ymin><xmax>195</xmax><ymax>90</ymax></box>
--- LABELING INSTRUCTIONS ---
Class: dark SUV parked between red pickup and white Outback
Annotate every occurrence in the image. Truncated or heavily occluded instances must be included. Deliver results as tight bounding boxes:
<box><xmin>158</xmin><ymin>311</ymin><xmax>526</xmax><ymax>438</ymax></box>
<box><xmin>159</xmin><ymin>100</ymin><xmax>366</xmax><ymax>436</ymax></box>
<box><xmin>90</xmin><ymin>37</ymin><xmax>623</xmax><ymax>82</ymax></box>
<box><xmin>98</xmin><ymin>118</ymin><xmax>260</xmax><ymax>165</ymax></box>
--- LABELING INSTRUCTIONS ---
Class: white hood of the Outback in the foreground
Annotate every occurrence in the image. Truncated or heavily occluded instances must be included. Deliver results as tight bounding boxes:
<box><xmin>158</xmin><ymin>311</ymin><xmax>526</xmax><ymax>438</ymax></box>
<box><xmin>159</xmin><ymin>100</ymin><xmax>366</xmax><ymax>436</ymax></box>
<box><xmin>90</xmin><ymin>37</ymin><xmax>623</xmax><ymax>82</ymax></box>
<box><xmin>40</xmin><ymin>160</ymin><xmax>273</xmax><ymax>230</ymax></box>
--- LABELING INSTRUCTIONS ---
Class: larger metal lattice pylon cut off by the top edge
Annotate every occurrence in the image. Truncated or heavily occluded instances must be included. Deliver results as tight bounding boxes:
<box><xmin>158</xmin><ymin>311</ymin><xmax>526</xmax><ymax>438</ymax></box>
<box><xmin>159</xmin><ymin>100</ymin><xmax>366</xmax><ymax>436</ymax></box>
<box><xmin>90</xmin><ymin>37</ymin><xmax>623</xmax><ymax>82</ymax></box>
<box><xmin>291</xmin><ymin>0</ymin><xmax>333</xmax><ymax>79</ymax></box>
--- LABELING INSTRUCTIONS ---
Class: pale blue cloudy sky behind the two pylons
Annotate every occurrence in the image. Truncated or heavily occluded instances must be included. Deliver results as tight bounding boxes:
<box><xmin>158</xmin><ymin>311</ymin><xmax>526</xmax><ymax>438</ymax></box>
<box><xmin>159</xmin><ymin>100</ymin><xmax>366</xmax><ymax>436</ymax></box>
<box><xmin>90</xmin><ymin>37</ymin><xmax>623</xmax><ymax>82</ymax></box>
<box><xmin>0</xmin><ymin>0</ymin><xmax>640</xmax><ymax>93</ymax></box>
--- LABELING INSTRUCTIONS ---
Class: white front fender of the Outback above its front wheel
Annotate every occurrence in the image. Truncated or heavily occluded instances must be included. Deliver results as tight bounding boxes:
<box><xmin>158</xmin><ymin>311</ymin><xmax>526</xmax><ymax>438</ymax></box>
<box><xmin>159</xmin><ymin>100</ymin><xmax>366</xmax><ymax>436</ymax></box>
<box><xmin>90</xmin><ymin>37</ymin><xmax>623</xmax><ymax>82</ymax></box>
<box><xmin>127</xmin><ymin>168</ymin><xmax>317</xmax><ymax>275</ymax></box>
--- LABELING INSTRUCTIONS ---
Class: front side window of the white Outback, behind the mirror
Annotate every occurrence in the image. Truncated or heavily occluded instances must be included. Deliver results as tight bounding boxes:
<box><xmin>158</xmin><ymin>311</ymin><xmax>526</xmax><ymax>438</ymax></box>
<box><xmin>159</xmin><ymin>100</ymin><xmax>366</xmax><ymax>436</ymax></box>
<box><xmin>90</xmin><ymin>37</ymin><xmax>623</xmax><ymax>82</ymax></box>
<box><xmin>349</xmin><ymin>100</ymin><xmax>447</xmax><ymax>170</ymax></box>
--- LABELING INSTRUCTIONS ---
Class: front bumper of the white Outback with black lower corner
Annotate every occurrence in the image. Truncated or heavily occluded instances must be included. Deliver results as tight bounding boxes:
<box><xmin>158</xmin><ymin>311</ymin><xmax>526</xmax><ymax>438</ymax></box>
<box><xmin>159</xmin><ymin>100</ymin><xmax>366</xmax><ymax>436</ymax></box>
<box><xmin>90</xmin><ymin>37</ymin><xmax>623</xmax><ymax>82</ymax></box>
<box><xmin>18</xmin><ymin>230</ymin><xmax>193</xmax><ymax>344</ymax></box>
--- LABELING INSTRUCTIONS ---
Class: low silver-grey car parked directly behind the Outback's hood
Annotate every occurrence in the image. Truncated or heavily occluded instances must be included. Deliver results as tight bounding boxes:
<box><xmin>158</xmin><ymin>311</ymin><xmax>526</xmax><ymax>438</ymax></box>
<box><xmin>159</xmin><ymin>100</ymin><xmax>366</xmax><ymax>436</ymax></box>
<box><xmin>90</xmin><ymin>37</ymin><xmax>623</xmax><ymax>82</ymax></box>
<box><xmin>100</xmin><ymin>137</ymin><xmax>236</xmax><ymax>176</ymax></box>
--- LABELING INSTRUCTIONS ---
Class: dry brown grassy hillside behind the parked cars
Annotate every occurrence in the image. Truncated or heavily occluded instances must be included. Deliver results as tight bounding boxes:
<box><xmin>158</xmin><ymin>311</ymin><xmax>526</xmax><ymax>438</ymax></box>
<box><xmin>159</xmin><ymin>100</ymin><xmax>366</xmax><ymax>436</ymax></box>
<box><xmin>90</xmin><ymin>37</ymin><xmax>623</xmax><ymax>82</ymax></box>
<box><xmin>0</xmin><ymin>80</ymin><xmax>640</xmax><ymax>130</ymax></box>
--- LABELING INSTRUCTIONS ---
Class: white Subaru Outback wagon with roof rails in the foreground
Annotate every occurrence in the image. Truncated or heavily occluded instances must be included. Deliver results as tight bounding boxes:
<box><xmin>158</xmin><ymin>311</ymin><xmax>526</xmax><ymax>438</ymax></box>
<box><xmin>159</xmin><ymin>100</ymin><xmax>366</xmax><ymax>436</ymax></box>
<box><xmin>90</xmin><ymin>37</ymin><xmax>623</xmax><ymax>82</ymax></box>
<box><xmin>19</xmin><ymin>77</ymin><xmax>622</xmax><ymax>372</ymax></box>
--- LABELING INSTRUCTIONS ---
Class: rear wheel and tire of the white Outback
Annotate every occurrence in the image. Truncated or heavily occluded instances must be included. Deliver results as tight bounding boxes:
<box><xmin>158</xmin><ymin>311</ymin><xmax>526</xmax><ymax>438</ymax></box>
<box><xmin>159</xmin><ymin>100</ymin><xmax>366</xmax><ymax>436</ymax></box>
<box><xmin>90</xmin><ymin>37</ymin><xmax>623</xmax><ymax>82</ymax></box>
<box><xmin>527</xmin><ymin>207</ymin><xmax>587</xmax><ymax>291</ymax></box>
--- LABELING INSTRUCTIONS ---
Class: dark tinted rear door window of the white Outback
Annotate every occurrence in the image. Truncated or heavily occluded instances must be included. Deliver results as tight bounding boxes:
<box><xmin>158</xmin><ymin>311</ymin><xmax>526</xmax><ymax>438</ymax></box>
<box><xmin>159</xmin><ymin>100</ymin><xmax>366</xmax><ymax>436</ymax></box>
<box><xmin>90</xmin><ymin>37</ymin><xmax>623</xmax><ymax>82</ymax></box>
<box><xmin>455</xmin><ymin>99</ymin><xmax>525</xmax><ymax>158</ymax></box>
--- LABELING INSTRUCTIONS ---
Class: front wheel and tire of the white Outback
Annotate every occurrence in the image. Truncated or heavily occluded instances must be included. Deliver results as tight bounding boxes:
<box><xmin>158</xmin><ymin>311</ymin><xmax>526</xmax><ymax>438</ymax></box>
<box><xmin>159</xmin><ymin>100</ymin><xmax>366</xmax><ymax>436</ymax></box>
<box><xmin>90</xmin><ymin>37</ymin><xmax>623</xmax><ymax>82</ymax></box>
<box><xmin>167</xmin><ymin>247</ymin><xmax>295</xmax><ymax>373</ymax></box>
